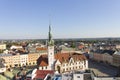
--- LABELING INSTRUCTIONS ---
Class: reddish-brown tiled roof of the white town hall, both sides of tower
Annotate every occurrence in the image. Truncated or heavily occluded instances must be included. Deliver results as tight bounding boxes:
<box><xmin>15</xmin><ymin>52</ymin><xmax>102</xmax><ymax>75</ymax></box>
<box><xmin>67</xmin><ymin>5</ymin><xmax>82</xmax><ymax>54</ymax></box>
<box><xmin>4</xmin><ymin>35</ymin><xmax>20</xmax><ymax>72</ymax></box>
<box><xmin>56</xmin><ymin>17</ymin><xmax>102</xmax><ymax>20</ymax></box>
<box><xmin>37</xmin><ymin>53</ymin><xmax>87</xmax><ymax>66</ymax></box>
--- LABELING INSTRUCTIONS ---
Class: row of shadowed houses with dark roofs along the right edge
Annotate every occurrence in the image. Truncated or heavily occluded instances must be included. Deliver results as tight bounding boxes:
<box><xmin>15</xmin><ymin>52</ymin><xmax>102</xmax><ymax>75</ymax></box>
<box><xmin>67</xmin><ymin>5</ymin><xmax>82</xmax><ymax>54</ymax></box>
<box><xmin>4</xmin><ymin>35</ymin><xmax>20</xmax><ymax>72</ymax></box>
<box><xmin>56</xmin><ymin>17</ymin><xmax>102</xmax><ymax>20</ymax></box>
<box><xmin>89</xmin><ymin>50</ymin><xmax>120</xmax><ymax>67</ymax></box>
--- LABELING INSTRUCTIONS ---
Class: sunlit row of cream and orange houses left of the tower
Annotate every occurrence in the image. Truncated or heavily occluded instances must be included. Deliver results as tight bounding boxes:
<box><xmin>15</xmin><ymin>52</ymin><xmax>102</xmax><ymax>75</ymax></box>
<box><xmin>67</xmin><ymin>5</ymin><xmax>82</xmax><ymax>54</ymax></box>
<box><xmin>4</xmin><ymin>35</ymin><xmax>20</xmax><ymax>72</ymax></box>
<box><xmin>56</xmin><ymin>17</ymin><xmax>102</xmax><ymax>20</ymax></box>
<box><xmin>0</xmin><ymin>53</ymin><xmax>41</xmax><ymax>68</ymax></box>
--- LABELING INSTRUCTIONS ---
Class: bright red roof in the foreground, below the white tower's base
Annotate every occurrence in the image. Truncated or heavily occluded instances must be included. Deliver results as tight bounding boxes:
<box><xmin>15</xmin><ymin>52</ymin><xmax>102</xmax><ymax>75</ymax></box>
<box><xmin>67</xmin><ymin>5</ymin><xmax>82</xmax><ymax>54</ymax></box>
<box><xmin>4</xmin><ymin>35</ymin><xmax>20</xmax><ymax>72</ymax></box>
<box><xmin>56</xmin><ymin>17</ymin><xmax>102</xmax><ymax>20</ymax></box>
<box><xmin>35</xmin><ymin>70</ymin><xmax>54</xmax><ymax>79</ymax></box>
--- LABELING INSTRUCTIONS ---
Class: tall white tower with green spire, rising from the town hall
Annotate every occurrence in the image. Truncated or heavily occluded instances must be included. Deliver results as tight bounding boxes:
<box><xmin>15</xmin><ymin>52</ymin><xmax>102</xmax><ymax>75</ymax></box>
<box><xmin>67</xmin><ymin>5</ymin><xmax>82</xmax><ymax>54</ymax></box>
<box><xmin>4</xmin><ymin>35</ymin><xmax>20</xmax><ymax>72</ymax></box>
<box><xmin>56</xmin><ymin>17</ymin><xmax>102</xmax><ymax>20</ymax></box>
<box><xmin>47</xmin><ymin>25</ymin><xmax>55</xmax><ymax>70</ymax></box>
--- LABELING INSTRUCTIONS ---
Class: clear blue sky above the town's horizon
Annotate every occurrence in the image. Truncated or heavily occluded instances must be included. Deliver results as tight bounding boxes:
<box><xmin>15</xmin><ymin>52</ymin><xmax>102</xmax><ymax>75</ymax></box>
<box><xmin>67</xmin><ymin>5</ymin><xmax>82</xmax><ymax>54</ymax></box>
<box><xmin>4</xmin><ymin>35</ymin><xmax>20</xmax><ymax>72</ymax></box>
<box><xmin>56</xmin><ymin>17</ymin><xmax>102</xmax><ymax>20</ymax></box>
<box><xmin>0</xmin><ymin>0</ymin><xmax>120</xmax><ymax>39</ymax></box>
